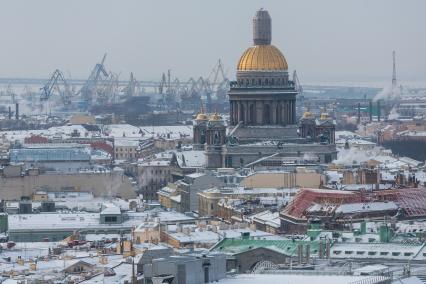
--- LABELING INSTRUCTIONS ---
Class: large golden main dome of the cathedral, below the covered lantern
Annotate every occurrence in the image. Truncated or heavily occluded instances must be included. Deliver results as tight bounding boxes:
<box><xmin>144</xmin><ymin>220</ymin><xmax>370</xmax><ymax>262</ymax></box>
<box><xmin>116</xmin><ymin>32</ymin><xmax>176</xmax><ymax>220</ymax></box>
<box><xmin>237</xmin><ymin>45</ymin><xmax>288</xmax><ymax>71</ymax></box>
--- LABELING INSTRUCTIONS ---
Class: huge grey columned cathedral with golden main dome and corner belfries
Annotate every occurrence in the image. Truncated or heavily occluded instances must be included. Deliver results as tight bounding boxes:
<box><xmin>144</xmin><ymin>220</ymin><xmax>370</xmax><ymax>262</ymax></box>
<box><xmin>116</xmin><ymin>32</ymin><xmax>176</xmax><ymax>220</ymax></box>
<box><xmin>193</xmin><ymin>9</ymin><xmax>337</xmax><ymax>168</ymax></box>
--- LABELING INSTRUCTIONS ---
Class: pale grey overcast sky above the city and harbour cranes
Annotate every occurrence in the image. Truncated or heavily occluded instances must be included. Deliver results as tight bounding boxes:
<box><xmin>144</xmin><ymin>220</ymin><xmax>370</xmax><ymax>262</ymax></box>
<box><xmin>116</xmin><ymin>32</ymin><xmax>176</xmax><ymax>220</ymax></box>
<box><xmin>0</xmin><ymin>0</ymin><xmax>426</xmax><ymax>82</ymax></box>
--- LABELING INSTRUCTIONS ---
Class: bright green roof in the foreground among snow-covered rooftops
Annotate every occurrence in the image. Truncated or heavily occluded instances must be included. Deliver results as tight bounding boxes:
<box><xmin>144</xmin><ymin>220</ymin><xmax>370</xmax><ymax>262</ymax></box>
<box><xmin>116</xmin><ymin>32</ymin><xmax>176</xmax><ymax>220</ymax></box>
<box><xmin>210</xmin><ymin>238</ymin><xmax>325</xmax><ymax>256</ymax></box>
